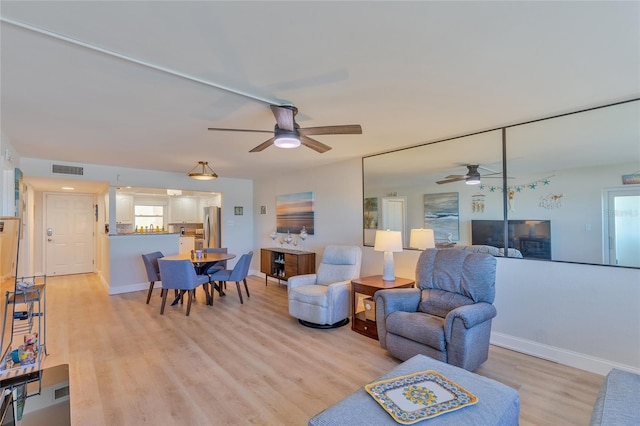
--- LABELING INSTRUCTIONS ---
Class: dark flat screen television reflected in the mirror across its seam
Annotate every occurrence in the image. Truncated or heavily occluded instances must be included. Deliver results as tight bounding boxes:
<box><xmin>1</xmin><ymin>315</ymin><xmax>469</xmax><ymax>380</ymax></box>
<box><xmin>471</xmin><ymin>219</ymin><xmax>551</xmax><ymax>260</ymax></box>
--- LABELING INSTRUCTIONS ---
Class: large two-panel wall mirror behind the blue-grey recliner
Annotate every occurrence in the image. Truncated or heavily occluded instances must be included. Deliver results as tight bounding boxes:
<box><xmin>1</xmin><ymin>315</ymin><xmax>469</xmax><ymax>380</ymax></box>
<box><xmin>362</xmin><ymin>99</ymin><xmax>640</xmax><ymax>268</ymax></box>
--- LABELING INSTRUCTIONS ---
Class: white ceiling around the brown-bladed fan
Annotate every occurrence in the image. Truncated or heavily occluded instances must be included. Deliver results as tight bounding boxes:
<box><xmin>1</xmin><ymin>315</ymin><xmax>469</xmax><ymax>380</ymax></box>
<box><xmin>0</xmin><ymin>0</ymin><xmax>640</xmax><ymax>191</ymax></box>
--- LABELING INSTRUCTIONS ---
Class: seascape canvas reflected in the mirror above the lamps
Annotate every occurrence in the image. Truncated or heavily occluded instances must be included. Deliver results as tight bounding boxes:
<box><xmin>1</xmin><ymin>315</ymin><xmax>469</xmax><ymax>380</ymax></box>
<box><xmin>424</xmin><ymin>192</ymin><xmax>460</xmax><ymax>242</ymax></box>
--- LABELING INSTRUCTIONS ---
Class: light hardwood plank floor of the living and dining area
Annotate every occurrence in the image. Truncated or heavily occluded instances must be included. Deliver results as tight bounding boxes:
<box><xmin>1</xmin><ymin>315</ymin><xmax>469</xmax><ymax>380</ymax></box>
<box><xmin>37</xmin><ymin>274</ymin><xmax>603</xmax><ymax>426</ymax></box>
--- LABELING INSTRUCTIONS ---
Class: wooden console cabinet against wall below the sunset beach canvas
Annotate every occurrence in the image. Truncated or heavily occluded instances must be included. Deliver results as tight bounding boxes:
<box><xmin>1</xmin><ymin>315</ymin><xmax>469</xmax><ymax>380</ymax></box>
<box><xmin>260</xmin><ymin>248</ymin><xmax>316</xmax><ymax>285</ymax></box>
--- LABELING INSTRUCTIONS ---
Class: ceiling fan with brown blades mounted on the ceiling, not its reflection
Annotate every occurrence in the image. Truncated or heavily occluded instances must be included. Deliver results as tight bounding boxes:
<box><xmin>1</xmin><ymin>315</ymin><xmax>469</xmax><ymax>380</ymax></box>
<box><xmin>209</xmin><ymin>105</ymin><xmax>362</xmax><ymax>154</ymax></box>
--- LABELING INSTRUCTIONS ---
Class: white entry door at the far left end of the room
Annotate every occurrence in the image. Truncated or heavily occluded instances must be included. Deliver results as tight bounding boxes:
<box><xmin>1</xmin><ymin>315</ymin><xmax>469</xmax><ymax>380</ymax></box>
<box><xmin>44</xmin><ymin>194</ymin><xmax>95</xmax><ymax>275</ymax></box>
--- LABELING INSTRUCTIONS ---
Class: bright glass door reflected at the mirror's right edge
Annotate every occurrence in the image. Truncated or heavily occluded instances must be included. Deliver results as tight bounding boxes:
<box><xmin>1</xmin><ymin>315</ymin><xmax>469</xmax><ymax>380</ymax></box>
<box><xmin>604</xmin><ymin>188</ymin><xmax>640</xmax><ymax>268</ymax></box>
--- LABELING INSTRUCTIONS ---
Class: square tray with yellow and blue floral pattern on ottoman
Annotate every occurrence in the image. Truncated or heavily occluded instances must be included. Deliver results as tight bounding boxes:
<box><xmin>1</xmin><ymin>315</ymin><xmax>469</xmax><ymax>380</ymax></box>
<box><xmin>364</xmin><ymin>370</ymin><xmax>478</xmax><ymax>425</ymax></box>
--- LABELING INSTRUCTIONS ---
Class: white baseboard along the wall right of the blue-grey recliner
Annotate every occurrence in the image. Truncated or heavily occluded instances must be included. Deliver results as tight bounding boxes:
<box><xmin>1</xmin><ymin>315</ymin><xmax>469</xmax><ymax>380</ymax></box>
<box><xmin>491</xmin><ymin>332</ymin><xmax>640</xmax><ymax>376</ymax></box>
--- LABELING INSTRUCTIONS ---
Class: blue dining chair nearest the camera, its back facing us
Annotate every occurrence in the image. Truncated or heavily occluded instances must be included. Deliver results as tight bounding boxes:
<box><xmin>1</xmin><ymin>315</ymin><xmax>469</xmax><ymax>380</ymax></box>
<box><xmin>158</xmin><ymin>259</ymin><xmax>209</xmax><ymax>316</ymax></box>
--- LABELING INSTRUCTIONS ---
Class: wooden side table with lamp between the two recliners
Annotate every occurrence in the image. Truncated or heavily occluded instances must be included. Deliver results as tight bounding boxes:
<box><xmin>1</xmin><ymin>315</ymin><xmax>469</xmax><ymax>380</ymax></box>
<box><xmin>351</xmin><ymin>275</ymin><xmax>415</xmax><ymax>340</ymax></box>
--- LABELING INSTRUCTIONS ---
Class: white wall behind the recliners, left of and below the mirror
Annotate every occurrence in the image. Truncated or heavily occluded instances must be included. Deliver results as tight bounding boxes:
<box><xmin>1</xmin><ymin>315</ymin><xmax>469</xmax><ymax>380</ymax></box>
<box><xmin>254</xmin><ymin>159</ymin><xmax>640</xmax><ymax>374</ymax></box>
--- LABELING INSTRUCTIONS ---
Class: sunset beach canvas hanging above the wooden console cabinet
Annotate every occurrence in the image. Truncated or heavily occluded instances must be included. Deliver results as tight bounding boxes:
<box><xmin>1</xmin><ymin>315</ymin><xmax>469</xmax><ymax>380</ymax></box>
<box><xmin>276</xmin><ymin>192</ymin><xmax>314</xmax><ymax>235</ymax></box>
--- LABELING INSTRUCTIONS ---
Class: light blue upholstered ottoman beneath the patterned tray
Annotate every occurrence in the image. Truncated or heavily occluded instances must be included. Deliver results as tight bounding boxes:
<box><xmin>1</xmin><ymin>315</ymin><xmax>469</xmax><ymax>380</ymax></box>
<box><xmin>309</xmin><ymin>355</ymin><xmax>520</xmax><ymax>426</ymax></box>
